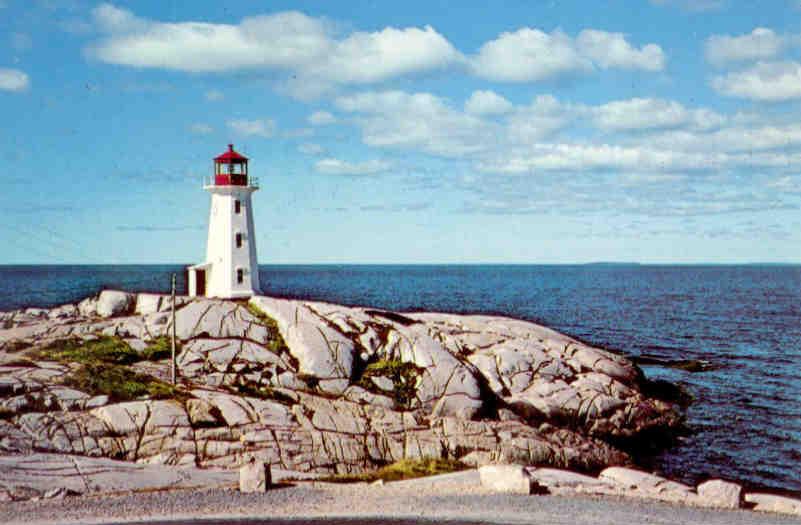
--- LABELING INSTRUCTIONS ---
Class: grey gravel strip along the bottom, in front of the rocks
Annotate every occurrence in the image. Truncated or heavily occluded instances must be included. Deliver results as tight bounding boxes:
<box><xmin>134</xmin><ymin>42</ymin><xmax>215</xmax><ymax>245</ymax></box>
<box><xmin>0</xmin><ymin>482</ymin><xmax>801</xmax><ymax>525</ymax></box>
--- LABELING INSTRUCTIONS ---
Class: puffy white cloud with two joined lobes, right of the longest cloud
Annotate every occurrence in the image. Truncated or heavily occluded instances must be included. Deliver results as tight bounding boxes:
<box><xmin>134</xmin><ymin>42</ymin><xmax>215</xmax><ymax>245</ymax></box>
<box><xmin>470</xmin><ymin>27</ymin><xmax>665</xmax><ymax>82</ymax></box>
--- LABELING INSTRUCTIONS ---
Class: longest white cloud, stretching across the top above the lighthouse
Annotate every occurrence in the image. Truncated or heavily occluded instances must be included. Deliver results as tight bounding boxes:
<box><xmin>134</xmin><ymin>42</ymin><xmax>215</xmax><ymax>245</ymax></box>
<box><xmin>87</xmin><ymin>4</ymin><xmax>460</xmax><ymax>93</ymax></box>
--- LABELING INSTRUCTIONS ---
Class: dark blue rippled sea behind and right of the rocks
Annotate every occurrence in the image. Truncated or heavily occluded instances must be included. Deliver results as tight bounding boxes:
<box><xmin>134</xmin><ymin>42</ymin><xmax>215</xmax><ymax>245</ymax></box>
<box><xmin>0</xmin><ymin>264</ymin><xmax>801</xmax><ymax>493</ymax></box>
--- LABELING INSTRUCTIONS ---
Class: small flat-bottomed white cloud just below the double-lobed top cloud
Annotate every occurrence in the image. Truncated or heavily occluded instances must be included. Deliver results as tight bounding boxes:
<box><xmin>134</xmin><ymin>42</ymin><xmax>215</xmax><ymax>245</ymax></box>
<box><xmin>594</xmin><ymin>98</ymin><xmax>723</xmax><ymax>131</ymax></box>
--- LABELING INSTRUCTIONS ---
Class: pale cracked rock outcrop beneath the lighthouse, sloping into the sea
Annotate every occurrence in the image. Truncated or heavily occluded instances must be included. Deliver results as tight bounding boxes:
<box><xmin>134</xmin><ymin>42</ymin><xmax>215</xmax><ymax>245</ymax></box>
<box><xmin>0</xmin><ymin>291</ymin><xmax>796</xmax><ymax>516</ymax></box>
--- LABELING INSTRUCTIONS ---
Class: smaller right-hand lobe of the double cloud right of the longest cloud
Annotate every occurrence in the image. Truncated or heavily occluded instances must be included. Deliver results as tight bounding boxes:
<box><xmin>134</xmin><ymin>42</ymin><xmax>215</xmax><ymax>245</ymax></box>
<box><xmin>576</xmin><ymin>29</ymin><xmax>665</xmax><ymax>71</ymax></box>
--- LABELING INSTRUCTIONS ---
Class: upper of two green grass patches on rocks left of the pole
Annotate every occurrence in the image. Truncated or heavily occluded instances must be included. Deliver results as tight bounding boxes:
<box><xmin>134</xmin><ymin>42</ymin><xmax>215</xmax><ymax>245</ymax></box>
<box><xmin>27</xmin><ymin>336</ymin><xmax>142</xmax><ymax>365</ymax></box>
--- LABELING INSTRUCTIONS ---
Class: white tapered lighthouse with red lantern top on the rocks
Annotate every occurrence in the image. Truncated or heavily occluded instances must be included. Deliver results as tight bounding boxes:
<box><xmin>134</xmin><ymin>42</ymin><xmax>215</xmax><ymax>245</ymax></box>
<box><xmin>187</xmin><ymin>144</ymin><xmax>260</xmax><ymax>299</ymax></box>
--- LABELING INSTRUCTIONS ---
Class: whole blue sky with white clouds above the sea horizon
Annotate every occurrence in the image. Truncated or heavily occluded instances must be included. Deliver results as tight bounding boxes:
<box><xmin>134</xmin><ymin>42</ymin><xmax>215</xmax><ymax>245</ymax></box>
<box><xmin>0</xmin><ymin>0</ymin><xmax>801</xmax><ymax>264</ymax></box>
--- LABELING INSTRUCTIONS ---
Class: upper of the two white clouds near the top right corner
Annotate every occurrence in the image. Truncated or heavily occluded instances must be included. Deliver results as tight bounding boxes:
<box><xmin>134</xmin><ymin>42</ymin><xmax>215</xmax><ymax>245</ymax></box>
<box><xmin>704</xmin><ymin>27</ymin><xmax>787</xmax><ymax>66</ymax></box>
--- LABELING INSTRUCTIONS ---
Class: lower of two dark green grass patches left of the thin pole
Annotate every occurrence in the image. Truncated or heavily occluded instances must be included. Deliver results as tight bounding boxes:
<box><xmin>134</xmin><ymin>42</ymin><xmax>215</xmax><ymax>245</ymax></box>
<box><xmin>64</xmin><ymin>363</ymin><xmax>184</xmax><ymax>401</ymax></box>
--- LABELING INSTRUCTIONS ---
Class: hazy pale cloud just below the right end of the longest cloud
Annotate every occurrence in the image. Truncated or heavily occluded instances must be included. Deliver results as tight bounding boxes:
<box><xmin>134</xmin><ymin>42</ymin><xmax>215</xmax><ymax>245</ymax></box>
<box><xmin>336</xmin><ymin>91</ymin><xmax>500</xmax><ymax>157</ymax></box>
